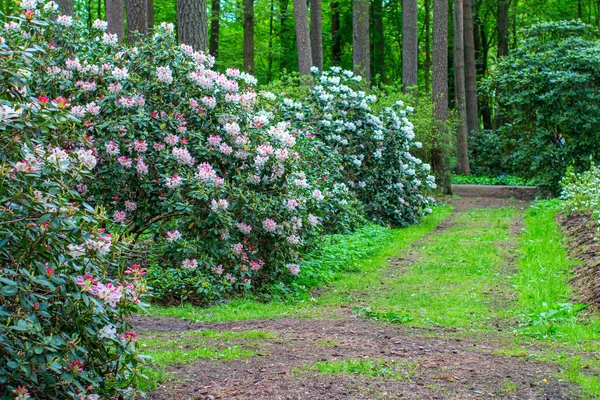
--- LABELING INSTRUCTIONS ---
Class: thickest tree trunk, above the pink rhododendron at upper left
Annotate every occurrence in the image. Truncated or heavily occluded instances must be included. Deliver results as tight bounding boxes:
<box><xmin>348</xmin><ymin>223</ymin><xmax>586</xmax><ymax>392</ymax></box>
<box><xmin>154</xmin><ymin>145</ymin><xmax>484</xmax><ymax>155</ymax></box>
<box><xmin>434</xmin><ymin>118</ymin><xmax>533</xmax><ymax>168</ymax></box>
<box><xmin>177</xmin><ymin>0</ymin><xmax>208</xmax><ymax>51</ymax></box>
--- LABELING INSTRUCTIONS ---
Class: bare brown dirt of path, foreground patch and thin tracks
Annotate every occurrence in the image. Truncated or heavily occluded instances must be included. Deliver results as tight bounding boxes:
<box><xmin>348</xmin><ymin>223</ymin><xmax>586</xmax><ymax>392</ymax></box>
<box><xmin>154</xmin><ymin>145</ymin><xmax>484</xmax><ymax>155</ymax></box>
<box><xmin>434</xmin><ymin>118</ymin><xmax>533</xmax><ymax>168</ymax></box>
<box><xmin>134</xmin><ymin>187</ymin><xmax>577</xmax><ymax>399</ymax></box>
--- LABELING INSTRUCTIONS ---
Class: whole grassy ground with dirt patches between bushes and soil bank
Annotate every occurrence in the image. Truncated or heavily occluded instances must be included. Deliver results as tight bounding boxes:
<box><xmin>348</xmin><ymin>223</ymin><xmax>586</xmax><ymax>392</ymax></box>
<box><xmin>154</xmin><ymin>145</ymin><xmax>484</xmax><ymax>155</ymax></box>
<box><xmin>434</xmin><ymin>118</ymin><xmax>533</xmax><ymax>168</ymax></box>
<box><xmin>135</xmin><ymin>192</ymin><xmax>600</xmax><ymax>399</ymax></box>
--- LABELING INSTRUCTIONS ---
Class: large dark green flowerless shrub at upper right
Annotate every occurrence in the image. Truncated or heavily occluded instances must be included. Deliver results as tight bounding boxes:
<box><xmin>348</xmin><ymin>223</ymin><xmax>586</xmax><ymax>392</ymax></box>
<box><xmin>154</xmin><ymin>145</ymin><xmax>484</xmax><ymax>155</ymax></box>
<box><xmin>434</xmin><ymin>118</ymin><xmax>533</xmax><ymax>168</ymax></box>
<box><xmin>482</xmin><ymin>21</ymin><xmax>600</xmax><ymax>192</ymax></box>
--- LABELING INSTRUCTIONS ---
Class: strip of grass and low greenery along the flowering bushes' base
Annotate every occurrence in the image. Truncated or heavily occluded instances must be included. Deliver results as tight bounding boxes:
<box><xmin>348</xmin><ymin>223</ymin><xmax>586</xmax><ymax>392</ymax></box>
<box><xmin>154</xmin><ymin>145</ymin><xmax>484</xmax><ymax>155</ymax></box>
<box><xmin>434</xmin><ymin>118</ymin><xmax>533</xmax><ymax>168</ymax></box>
<box><xmin>148</xmin><ymin>206</ymin><xmax>452</xmax><ymax>322</ymax></box>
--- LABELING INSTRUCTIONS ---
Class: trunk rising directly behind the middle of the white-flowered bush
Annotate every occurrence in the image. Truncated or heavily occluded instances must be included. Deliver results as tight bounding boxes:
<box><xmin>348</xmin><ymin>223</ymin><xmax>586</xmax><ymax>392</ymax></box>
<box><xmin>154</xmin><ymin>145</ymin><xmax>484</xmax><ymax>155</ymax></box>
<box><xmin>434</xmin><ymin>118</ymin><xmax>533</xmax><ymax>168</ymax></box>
<box><xmin>352</xmin><ymin>0</ymin><xmax>371</xmax><ymax>85</ymax></box>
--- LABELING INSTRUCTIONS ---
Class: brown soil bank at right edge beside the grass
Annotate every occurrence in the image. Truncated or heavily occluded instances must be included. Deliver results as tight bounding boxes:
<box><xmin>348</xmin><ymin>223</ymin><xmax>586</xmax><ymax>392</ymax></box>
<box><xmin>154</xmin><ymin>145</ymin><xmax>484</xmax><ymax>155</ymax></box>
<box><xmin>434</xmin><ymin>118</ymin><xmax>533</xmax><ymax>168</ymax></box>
<box><xmin>557</xmin><ymin>213</ymin><xmax>600</xmax><ymax>309</ymax></box>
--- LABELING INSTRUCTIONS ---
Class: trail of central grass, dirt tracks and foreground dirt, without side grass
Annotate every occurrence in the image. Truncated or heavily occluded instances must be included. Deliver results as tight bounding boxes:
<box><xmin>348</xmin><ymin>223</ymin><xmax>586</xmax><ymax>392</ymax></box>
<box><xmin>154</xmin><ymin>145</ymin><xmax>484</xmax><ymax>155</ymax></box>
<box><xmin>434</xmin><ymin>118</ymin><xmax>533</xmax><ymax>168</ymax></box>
<box><xmin>134</xmin><ymin>187</ymin><xmax>577</xmax><ymax>399</ymax></box>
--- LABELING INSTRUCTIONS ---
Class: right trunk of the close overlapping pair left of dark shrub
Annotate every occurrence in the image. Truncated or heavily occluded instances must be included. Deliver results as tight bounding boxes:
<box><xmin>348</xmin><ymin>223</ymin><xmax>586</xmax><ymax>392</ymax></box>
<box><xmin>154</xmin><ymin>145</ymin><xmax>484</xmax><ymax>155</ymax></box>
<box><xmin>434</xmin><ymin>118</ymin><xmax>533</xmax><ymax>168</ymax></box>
<box><xmin>463</xmin><ymin>0</ymin><xmax>479</xmax><ymax>135</ymax></box>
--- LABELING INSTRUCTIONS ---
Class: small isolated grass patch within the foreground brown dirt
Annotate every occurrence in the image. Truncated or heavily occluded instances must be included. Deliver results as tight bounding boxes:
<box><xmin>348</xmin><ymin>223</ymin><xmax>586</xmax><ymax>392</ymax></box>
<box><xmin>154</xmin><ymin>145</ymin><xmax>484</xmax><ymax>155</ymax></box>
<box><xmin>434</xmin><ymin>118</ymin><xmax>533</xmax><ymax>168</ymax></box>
<box><xmin>299</xmin><ymin>358</ymin><xmax>417</xmax><ymax>381</ymax></box>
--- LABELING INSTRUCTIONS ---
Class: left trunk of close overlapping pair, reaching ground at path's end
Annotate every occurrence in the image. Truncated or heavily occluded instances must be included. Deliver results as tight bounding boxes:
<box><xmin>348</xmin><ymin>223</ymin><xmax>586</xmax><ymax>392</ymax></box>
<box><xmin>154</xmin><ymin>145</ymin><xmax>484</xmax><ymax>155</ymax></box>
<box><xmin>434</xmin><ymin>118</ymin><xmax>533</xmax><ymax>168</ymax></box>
<box><xmin>454</xmin><ymin>0</ymin><xmax>471</xmax><ymax>175</ymax></box>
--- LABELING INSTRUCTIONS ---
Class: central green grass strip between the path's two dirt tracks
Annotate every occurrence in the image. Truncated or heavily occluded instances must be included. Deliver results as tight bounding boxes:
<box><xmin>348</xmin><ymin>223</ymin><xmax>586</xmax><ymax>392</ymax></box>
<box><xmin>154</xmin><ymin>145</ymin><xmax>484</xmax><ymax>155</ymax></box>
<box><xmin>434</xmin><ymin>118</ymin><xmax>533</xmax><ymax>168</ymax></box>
<box><xmin>336</xmin><ymin>207</ymin><xmax>517</xmax><ymax>331</ymax></box>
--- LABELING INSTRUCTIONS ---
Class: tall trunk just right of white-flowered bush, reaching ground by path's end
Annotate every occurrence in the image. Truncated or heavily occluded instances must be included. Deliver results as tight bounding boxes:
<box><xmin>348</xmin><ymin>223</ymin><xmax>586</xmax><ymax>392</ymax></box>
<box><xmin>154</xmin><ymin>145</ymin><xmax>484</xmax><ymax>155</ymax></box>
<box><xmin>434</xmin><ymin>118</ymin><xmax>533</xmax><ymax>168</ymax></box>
<box><xmin>432</xmin><ymin>0</ymin><xmax>452</xmax><ymax>193</ymax></box>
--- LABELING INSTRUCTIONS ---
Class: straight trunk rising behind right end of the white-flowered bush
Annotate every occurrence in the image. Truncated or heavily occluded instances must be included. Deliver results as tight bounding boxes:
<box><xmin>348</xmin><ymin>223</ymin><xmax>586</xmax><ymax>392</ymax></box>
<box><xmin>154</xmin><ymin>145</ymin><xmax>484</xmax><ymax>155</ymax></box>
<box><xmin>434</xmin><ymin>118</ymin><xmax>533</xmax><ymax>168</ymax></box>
<box><xmin>402</xmin><ymin>0</ymin><xmax>419</xmax><ymax>93</ymax></box>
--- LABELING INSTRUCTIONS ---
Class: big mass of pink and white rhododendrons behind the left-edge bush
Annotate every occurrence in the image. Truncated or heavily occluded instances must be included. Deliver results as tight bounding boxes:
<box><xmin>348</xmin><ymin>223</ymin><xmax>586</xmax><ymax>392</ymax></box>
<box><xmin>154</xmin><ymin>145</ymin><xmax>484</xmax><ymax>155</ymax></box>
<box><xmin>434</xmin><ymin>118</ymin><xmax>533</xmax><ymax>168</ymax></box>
<box><xmin>1</xmin><ymin>1</ymin><xmax>433</xmax><ymax>312</ymax></box>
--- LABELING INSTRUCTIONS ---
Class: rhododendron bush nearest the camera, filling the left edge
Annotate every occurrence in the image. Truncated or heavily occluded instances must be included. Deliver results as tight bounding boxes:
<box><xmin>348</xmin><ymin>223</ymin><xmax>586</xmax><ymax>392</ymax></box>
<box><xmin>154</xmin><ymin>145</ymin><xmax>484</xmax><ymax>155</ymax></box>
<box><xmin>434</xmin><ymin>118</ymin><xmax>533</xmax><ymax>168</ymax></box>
<box><xmin>0</xmin><ymin>14</ymin><xmax>146</xmax><ymax>400</ymax></box>
